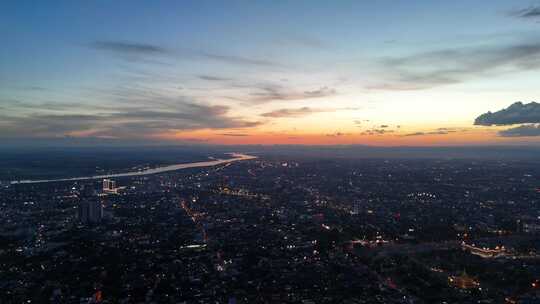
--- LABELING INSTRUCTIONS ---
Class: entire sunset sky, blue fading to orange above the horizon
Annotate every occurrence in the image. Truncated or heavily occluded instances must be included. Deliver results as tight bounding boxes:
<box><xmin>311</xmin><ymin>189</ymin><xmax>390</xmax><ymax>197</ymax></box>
<box><xmin>0</xmin><ymin>0</ymin><xmax>540</xmax><ymax>146</ymax></box>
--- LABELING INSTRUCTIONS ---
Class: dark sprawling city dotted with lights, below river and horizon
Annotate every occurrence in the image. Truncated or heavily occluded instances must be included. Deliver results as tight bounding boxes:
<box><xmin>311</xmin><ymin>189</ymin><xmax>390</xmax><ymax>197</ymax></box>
<box><xmin>0</xmin><ymin>155</ymin><xmax>540</xmax><ymax>304</ymax></box>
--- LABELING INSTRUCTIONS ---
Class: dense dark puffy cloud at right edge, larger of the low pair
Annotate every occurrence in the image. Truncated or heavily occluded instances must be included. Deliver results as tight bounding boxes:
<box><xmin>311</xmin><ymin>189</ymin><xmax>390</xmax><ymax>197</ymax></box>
<box><xmin>474</xmin><ymin>102</ymin><xmax>540</xmax><ymax>126</ymax></box>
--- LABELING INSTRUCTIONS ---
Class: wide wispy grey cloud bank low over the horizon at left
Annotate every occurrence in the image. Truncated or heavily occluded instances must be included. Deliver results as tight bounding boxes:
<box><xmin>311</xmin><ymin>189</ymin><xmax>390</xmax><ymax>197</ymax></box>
<box><xmin>0</xmin><ymin>97</ymin><xmax>261</xmax><ymax>138</ymax></box>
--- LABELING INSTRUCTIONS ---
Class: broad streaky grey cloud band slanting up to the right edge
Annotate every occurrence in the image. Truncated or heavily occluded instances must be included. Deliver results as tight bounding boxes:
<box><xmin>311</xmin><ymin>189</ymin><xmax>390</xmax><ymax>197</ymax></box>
<box><xmin>369</xmin><ymin>42</ymin><xmax>540</xmax><ymax>90</ymax></box>
